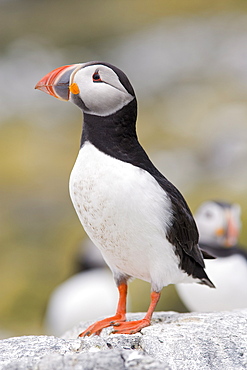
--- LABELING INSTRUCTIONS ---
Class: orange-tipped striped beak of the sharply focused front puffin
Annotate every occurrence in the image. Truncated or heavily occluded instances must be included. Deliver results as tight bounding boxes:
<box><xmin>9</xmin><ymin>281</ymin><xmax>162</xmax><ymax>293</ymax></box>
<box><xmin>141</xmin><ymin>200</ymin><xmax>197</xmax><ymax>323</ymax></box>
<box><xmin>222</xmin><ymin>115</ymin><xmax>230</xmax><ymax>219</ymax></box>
<box><xmin>35</xmin><ymin>64</ymin><xmax>82</xmax><ymax>101</ymax></box>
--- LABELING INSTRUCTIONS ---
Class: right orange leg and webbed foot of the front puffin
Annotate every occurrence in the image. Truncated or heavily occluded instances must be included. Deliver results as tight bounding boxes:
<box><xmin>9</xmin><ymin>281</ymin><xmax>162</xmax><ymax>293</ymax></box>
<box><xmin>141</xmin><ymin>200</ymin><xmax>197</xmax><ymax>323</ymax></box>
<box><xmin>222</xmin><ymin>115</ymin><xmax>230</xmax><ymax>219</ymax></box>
<box><xmin>113</xmin><ymin>292</ymin><xmax>161</xmax><ymax>334</ymax></box>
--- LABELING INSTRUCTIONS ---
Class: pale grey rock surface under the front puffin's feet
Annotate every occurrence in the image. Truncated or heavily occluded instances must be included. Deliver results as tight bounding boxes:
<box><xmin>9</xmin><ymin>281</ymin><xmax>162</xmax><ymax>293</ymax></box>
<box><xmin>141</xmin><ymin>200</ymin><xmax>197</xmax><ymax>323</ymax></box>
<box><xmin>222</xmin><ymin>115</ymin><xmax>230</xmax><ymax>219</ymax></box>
<box><xmin>0</xmin><ymin>310</ymin><xmax>247</xmax><ymax>370</ymax></box>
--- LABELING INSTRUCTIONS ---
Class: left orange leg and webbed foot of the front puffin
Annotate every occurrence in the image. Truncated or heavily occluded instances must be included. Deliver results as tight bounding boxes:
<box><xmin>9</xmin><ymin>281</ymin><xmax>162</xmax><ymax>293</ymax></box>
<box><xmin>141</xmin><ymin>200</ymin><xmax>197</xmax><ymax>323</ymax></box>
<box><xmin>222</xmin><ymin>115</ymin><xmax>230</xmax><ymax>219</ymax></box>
<box><xmin>79</xmin><ymin>283</ymin><xmax>127</xmax><ymax>337</ymax></box>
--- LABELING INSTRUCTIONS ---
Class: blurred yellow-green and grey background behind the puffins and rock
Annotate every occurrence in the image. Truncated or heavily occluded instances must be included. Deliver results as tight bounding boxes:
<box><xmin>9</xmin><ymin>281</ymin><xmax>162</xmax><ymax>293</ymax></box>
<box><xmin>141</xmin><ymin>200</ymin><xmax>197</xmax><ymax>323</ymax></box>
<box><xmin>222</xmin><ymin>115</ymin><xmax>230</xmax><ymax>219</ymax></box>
<box><xmin>0</xmin><ymin>0</ymin><xmax>247</xmax><ymax>336</ymax></box>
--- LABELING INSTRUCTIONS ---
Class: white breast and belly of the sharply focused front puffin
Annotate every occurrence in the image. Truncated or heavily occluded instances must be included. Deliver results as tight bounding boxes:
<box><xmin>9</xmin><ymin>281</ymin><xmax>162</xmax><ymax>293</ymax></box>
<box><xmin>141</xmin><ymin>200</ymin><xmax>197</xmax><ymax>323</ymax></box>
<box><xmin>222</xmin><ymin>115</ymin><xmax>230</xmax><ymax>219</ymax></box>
<box><xmin>70</xmin><ymin>143</ymin><xmax>193</xmax><ymax>290</ymax></box>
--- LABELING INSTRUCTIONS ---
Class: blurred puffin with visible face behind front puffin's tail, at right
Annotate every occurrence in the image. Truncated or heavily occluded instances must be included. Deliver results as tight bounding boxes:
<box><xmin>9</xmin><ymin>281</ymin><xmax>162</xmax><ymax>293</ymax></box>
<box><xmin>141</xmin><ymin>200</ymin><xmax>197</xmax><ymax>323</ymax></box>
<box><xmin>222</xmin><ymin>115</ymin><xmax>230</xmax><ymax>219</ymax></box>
<box><xmin>176</xmin><ymin>200</ymin><xmax>247</xmax><ymax>312</ymax></box>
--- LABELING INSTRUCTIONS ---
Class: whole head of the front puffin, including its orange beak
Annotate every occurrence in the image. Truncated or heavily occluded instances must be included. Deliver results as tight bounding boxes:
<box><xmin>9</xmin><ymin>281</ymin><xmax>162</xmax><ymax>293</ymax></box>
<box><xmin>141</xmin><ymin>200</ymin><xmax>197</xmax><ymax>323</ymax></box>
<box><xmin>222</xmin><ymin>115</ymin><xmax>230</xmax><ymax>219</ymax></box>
<box><xmin>36</xmin><ymin>62</ymin><xmax>135</xmax><ymax>117</ymax></box>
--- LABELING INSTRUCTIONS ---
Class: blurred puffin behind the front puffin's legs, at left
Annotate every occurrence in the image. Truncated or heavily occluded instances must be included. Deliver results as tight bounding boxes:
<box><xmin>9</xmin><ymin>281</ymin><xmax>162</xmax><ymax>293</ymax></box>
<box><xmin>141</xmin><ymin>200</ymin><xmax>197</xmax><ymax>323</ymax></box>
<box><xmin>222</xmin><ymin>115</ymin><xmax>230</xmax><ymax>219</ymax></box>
<box><xmin>43</xmin><ymin>238</ymin><xmax>119</xmax><ymax>336</ymax></box>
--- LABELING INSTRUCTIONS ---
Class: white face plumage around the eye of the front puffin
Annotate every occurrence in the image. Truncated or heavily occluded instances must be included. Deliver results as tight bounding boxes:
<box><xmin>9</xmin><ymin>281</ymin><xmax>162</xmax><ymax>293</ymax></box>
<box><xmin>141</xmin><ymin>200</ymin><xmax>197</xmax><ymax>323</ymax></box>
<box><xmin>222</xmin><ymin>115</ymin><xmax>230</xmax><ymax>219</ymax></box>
<box><xmin>70</xmin><ymin>64</ymin><xmax>134</xmax><ymax>116</ymax></box>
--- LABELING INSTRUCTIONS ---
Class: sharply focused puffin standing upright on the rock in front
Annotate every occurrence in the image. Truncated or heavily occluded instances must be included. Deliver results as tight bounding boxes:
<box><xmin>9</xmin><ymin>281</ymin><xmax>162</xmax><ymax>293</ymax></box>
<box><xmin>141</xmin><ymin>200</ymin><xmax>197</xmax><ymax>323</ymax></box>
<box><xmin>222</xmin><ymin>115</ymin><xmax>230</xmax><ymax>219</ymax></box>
<box><xmin>35</xmin><ymin>61</ymin><xmax>214</xmax><ymax>337</ymax></box>
